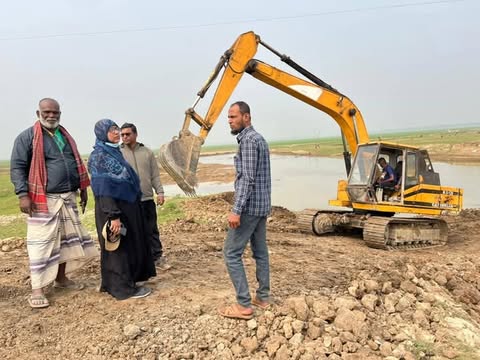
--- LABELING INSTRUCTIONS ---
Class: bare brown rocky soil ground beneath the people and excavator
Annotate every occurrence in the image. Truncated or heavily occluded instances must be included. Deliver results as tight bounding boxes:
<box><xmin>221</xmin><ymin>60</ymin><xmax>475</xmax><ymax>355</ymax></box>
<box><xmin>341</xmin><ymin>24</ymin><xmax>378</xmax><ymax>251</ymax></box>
<box><xmin>0</xmin><ymin>193</ymin><xmax>480</xmax><ymax>360</ymax></box>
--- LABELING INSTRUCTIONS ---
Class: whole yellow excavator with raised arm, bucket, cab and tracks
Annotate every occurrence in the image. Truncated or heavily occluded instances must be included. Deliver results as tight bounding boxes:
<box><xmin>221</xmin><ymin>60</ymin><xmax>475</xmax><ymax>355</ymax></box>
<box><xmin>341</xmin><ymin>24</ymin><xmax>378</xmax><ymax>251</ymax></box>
<box><xmin>159</xmin><ymin>32</ymin><xmax>463</xmax><ymax>250</ymax></box>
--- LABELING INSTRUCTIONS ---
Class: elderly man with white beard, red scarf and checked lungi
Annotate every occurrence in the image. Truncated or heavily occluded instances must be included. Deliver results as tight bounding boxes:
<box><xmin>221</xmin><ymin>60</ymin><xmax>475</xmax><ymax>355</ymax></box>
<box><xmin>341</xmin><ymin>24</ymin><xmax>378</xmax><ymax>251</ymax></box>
<box><xmin>10</xmin><ymin>98</ymin><xmax>98</xmax><ymax>308</ymax></box>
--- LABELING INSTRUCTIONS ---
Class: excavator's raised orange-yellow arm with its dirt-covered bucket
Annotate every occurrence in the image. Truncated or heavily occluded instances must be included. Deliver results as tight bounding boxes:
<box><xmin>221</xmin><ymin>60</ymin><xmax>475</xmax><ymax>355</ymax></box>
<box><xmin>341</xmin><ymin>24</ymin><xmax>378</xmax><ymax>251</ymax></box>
<box><xmin>159</xmin><ymin>32</ymin><xmax>369</xmax><ymax>195</ymax></box>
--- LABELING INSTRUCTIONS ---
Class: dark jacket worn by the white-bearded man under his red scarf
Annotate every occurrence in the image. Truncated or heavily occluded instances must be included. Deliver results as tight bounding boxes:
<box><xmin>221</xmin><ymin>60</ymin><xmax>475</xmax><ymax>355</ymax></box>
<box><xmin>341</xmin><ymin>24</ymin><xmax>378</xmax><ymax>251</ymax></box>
<box><xmin>10</xmin><ymin>126</ymin><xmax>80</xmax><ymax>196</ymax></box>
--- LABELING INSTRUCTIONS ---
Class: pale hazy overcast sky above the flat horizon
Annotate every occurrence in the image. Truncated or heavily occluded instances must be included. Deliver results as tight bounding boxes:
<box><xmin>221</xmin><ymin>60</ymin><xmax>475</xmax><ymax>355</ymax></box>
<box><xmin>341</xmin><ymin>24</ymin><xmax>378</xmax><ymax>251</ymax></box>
<box><xmin>0</xmin><ymin>0</ymin><xmax>480</xmax><ymax>159</ymax></box>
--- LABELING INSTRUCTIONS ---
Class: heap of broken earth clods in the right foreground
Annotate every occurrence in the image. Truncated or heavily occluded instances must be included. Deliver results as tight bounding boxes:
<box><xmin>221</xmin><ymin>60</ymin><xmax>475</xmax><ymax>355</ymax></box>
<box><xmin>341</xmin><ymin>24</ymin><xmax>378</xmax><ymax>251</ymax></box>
<box><xmin>94</xmin><ymin>264</ymin><xmax>480</xmax><ymax>360</ymax></box>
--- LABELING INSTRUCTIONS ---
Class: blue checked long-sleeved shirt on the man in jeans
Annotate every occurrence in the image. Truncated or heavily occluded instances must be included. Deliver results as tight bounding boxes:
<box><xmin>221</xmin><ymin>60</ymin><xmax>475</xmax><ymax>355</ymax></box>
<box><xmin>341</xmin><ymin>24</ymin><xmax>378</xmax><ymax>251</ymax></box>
<box><xmin>232</xmin><ymin>126</ymin><xmax>272</xmax><ymax>216</ymax></box>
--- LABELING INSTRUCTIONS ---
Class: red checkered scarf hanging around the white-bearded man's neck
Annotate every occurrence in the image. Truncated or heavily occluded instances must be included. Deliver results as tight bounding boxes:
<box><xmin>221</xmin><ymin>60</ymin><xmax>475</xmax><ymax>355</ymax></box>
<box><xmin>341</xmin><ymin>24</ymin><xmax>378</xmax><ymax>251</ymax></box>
<box><xmin>28</xmin><ymin>121</ymin><xmax>90</xmax><ymax>213</ymax></box>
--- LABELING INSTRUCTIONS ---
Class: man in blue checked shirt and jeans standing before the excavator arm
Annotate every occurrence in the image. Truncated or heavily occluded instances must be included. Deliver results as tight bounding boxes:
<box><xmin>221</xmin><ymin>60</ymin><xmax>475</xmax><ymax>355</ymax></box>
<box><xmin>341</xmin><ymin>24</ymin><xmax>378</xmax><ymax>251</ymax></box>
<box><xmin>219</xmin><ymin>101</ymin><xmax>271</xmax><ymax>319</ymax></box>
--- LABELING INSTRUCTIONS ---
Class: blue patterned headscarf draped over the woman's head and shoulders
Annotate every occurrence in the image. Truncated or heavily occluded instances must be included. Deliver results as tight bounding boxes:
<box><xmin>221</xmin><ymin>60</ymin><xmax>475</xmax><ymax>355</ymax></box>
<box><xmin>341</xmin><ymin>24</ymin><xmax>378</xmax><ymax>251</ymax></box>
<box><xmin>88</xmin><ymin>119</ymin><xmax>141</xmax><ymax>203</ymax></box>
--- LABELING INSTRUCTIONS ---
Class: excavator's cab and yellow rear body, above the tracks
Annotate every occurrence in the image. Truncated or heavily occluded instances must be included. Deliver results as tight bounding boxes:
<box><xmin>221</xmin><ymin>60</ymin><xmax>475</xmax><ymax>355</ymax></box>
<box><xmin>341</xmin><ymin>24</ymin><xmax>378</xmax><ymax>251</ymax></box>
<box><xmin>346</xmin><ymin>142</ymin><xmax>462</xmax><ymax>213</ymax></box>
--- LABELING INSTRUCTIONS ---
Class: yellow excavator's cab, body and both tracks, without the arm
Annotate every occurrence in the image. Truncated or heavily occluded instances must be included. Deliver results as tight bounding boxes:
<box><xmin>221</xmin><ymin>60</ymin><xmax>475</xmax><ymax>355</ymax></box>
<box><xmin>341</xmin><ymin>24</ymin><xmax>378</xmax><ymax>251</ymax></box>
<box><xmin>308</xmin><ymin>142</ymin><xmax>463</xmax><ymax>250</ymax></box>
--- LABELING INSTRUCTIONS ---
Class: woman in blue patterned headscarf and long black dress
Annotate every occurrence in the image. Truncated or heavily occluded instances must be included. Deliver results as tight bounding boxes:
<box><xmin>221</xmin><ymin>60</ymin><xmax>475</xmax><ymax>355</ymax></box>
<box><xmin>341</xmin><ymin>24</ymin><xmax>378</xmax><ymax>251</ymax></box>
<box><xmin>88</xmin><ymin>119</ymin><xmax>156</xmax><ymax>300</ymax></box>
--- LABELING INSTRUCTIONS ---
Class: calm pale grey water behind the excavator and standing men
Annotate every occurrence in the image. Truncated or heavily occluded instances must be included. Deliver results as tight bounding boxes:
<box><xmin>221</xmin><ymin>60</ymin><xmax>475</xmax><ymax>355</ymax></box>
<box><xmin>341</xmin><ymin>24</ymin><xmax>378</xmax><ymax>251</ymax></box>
<box><xmin>164</xmin><ymin>154</ymin><xmax>480</xmax><ymax>211</ymax></box>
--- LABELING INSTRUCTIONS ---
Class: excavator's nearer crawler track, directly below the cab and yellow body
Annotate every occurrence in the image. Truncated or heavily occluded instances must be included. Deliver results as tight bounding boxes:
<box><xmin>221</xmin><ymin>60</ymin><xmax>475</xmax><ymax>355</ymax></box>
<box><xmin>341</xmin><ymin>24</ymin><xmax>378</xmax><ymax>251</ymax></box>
<box><xmin>363</xmin><ymin>216</ymin><xmax>448</xmax><ymax>250</ymax></box>
